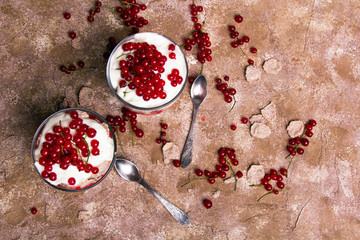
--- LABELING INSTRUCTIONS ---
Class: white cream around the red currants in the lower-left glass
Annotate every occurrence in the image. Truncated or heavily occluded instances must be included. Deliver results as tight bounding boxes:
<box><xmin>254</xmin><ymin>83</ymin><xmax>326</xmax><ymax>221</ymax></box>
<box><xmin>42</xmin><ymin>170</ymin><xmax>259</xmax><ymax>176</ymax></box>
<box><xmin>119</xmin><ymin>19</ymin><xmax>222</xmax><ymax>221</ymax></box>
<box><xmin>34</xmin><ymin>111</ymin><xmax>114</xmax><ymax>188</ymax></box>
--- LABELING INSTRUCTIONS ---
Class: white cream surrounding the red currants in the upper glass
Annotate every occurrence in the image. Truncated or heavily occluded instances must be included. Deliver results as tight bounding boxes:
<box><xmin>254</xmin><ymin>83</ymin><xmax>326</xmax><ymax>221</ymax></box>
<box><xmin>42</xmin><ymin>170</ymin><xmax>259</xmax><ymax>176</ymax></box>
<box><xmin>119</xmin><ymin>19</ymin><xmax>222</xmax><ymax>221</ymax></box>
<box><xmin>108</xmin><ymin>32</ymin><xmax>187</xmax><ymax>108</ymax></box>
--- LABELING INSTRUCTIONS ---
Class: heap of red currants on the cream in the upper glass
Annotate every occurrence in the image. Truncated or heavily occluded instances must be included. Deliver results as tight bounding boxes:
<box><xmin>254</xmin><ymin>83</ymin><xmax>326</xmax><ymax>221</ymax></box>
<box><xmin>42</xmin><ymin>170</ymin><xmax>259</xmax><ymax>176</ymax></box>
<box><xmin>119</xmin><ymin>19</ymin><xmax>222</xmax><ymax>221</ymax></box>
<box><xmin>119</xmin><ymin>42</ymin><xmax>183</xmax><ymax>101</ymax></box>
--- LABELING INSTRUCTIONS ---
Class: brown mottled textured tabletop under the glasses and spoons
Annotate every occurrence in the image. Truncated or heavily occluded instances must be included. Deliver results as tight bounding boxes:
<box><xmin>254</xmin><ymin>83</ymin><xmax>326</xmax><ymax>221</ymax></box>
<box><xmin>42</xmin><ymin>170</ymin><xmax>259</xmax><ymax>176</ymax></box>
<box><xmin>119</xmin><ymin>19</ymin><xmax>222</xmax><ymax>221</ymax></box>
<box><xmin>0</xmin><ymin>0</ymin><xmax>360</xmax><ymax>239</ymax></box>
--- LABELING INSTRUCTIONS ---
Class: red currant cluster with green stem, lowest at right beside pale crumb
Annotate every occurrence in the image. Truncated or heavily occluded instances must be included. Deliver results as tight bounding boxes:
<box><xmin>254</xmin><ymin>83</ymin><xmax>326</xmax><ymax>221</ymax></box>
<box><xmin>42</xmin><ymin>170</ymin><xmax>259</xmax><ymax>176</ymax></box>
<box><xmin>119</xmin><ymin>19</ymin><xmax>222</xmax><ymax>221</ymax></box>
<box><xmin>255</xmin><ymin>168</ymin><xmax>287</xmax><ymax>201</ymax></box>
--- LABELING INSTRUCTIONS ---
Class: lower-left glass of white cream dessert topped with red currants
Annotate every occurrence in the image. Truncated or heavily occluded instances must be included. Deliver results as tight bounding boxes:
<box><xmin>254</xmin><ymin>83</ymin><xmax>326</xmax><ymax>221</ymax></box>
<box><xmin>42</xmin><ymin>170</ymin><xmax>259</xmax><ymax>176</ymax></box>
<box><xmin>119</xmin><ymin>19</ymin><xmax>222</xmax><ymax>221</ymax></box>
<box><xmin>31</xmin><ymin>108</ymin><xmax>116</xmax><ymax>192</ymax></box>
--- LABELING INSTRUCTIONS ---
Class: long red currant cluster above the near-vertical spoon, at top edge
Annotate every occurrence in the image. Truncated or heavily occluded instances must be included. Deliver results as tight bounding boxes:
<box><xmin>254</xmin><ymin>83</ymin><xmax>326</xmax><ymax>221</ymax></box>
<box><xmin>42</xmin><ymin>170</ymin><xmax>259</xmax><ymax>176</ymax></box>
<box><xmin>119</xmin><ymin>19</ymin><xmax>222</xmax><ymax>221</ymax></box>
<box><xmin>184</xmin><ymin>4</ymin><xmax>212</xmax><ymax>63</ymax></box>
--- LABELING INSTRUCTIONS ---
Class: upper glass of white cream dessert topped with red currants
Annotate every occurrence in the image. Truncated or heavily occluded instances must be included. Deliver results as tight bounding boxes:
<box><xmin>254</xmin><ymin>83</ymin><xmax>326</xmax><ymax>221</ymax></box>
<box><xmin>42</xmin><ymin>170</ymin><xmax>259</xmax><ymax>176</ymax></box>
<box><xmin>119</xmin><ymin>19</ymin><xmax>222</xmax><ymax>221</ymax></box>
<box><xmin>106</xmin><ymin>32</ymin><xmax>188</xmax><ymax>114</ymax></box>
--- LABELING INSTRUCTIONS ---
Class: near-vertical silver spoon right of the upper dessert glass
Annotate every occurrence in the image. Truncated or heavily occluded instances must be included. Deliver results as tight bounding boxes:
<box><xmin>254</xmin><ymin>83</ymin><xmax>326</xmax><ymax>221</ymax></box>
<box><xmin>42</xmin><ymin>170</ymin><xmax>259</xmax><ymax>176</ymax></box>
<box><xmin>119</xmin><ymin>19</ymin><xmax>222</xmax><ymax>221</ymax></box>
<box><xmin>180</xmin><ymin>75</ymin><xmax>207</xmax><ymax>168</ymax></box>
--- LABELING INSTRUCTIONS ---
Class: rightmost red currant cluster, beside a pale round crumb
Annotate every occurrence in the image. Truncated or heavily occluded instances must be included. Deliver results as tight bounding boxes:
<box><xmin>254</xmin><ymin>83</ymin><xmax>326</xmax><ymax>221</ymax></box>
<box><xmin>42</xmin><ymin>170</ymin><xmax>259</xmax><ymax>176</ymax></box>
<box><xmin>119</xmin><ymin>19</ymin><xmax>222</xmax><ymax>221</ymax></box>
<box><xmin>286</xmin><ymin>120</ymin><xmax>316</xmax><ymax>156</ymax></box>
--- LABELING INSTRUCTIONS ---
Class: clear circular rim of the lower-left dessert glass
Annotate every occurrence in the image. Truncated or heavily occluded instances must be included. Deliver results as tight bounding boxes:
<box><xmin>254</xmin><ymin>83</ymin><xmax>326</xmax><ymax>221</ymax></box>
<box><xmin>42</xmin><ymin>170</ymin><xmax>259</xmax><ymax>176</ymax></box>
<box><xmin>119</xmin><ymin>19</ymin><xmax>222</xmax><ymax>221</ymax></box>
<box><xmin>31</xmin><ymin>107</ymin><xmax>117</xmax><ymax>192</ymax></box>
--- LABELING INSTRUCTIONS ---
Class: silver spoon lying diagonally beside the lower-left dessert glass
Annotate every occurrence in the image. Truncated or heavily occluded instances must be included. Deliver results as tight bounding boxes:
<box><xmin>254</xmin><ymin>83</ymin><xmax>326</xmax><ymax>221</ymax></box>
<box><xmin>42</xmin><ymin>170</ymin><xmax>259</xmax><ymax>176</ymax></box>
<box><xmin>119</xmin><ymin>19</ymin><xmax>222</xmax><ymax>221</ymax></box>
<box><xmin>115</xmin><ymin>158</ymin><xmax>190</xmax><ymax>225</ymax></box>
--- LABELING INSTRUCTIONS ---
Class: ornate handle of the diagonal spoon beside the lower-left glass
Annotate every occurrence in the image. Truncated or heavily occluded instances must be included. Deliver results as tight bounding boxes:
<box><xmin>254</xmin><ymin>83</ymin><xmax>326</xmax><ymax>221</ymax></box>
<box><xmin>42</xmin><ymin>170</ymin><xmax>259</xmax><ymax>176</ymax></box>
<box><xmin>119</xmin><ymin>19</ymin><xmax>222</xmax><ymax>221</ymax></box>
<box><xmin>139</xmin><ymin>179</ymin><xmax>190</xmax><ymax>225</ymax></box>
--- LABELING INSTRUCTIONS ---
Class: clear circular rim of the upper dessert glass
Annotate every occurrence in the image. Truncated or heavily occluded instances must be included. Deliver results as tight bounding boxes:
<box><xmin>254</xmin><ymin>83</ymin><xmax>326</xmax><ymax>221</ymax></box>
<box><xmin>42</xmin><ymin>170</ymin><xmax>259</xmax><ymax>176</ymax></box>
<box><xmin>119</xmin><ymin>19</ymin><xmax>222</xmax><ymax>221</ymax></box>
<box><xmin>106</xmin><ymin>32</ymin><xmax>189</xmax><ymax>111</ymax></box>
